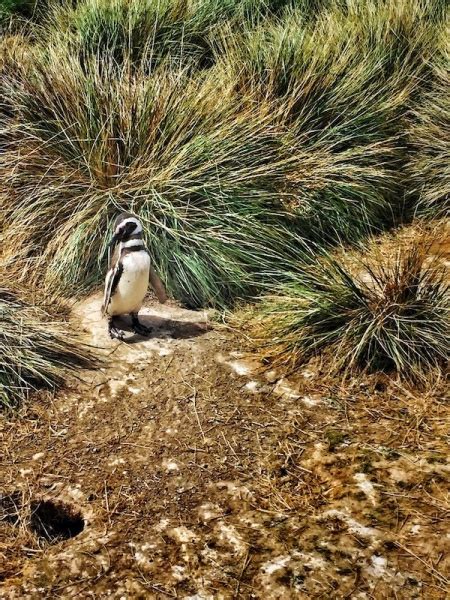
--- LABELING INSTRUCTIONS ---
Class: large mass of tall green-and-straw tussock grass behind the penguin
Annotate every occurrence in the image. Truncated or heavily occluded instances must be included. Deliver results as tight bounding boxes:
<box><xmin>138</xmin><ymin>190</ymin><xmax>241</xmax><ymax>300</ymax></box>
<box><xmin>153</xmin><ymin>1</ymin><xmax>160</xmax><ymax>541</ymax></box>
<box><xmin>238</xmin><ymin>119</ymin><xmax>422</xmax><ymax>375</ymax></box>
<box><xmin>0</xmin><ymin>0</ymin><xmax>444</xmax><ymax>306</ymax></box>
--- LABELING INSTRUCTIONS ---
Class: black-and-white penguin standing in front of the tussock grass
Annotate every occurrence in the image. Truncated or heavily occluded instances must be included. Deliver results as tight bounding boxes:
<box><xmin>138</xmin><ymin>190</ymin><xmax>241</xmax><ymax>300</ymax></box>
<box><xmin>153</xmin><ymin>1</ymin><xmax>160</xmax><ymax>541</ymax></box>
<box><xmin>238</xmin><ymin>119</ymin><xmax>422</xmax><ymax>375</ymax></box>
<box><xmin>102</xmin><ymin>213</ymin><xmax>167</xmax><ymax>340</ymax></box>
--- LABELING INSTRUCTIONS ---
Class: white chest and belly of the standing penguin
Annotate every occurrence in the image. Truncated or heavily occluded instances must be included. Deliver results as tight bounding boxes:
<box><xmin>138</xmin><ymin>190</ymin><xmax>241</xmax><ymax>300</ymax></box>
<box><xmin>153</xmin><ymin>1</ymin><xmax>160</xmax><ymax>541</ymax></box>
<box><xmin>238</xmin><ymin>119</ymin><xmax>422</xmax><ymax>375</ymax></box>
<box><xmin>108</xmin><ymin>250</ymin><xmax>150</xmax><ymax>315</ymax></box>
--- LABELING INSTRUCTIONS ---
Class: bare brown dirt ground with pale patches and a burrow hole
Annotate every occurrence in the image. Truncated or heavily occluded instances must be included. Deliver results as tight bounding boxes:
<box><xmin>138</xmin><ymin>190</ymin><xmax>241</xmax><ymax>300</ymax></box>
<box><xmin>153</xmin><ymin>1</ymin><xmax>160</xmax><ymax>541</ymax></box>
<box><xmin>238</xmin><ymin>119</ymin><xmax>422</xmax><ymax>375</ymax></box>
<box><xmin>0</xmin><ymin>296</ymin><xmax>450</xmax><ymax>600</ymax></box>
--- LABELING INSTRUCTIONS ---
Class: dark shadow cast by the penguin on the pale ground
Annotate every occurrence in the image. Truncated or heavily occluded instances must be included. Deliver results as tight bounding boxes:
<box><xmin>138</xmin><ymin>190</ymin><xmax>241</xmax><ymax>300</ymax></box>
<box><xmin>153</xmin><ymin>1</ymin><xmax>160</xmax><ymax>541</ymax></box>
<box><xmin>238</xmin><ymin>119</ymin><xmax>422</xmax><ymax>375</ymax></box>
<box><xmin>113</xmin><ymin>315</ymin><xmax>212</xmax><ymax>344</ymax></box>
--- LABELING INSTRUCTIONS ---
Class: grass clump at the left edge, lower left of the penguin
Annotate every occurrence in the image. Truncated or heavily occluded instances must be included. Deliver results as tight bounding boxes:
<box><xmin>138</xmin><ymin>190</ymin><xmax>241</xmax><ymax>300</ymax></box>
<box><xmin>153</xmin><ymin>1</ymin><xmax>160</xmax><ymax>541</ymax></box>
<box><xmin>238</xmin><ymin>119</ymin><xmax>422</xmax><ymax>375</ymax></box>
<box><xmin>0</xmin><ymin>287</ymin><xmax>94</xmax><ymax>408</ymax></box>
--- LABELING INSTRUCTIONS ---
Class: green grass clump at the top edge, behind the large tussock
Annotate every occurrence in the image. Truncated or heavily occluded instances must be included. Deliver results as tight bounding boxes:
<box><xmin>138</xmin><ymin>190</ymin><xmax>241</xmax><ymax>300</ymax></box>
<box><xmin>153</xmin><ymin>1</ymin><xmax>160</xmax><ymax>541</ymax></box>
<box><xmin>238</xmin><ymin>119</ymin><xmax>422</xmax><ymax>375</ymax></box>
<box><xmin>44</xmin><ymin>0</ymin><xmax>311</xmax><ymax>69</ymax></box>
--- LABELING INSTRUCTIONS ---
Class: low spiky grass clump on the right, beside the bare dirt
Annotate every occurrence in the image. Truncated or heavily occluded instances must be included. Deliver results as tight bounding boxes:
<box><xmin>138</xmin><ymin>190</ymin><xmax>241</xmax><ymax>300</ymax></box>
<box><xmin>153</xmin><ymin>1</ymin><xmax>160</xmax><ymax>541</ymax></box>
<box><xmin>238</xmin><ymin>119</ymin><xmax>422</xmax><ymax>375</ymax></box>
<box><xmin>250</xmin><ymin>238</ymin><xmax>450</xmax><ymax>380</ymax></box>
